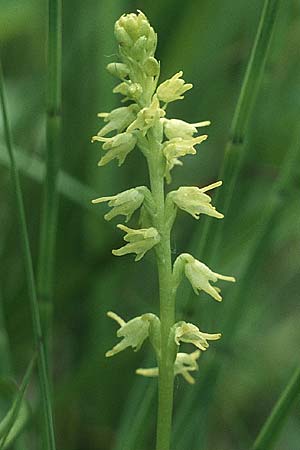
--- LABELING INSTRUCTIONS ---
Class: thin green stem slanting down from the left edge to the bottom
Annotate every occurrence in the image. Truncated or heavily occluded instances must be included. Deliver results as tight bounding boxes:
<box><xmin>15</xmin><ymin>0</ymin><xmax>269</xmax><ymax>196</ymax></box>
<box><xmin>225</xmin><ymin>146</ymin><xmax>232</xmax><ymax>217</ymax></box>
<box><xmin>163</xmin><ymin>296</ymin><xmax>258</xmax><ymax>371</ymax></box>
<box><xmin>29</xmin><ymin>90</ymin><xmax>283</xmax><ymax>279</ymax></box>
<box><xmin>0</xmin><ymin>61</ymin><xmax>56</xmax><ymax>450</ymax></box>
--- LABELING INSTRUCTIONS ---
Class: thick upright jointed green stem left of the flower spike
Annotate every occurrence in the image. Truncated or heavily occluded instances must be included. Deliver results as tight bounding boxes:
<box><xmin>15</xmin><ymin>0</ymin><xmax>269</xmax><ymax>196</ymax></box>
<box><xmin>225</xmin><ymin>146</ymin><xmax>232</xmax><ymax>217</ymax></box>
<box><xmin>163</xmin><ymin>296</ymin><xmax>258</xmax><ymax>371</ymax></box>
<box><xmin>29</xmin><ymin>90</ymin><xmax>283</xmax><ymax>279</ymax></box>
<box><xmin>38</xmin><ymin>0</ymin><xmax>62</xmax><ymax>334</ymax></box>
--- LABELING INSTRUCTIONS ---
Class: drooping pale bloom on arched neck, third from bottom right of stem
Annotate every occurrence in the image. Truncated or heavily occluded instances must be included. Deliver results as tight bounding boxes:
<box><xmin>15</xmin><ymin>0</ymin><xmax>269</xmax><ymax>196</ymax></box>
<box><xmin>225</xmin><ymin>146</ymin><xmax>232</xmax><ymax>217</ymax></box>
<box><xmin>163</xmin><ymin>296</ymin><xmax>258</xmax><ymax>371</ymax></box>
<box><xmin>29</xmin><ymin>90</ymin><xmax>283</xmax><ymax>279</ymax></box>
<box><xmin>173</xmin><ymin>253</ymin><xmax>235</xmax><ymax>302</ymax></box>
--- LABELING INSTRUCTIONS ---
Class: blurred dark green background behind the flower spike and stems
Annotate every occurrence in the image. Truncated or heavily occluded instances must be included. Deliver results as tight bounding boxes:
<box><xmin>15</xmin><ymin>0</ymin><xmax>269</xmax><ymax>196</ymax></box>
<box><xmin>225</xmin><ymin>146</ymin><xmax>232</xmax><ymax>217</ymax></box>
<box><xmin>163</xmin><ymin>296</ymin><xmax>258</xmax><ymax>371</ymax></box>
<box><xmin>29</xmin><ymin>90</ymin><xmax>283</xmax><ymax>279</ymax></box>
<box><xmin>0</xmin><ymin>0</ymin><xmax>300</xmax><ymax>450</ymax></box>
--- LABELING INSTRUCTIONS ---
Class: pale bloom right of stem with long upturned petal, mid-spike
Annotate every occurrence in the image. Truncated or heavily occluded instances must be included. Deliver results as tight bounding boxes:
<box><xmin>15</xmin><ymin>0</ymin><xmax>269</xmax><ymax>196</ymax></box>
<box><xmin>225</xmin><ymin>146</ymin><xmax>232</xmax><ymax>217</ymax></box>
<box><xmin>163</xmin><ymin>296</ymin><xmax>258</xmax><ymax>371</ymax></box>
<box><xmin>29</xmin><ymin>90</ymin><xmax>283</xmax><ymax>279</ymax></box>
<box><xmin>168</xmin><ymin>181</ymin><xmax>224</xmax><ymax>219</ymax></box>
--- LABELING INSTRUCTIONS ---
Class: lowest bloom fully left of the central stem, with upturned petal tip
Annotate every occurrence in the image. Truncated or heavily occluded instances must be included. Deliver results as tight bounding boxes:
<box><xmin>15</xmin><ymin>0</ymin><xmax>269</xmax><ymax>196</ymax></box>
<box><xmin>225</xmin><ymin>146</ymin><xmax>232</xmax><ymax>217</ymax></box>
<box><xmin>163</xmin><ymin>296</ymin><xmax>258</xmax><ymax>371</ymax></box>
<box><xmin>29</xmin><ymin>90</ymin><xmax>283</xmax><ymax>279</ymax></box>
<box><xmin>105</xmin><ymin>311</ymin><xmax>156</xmax><ymax>357</ymax></box>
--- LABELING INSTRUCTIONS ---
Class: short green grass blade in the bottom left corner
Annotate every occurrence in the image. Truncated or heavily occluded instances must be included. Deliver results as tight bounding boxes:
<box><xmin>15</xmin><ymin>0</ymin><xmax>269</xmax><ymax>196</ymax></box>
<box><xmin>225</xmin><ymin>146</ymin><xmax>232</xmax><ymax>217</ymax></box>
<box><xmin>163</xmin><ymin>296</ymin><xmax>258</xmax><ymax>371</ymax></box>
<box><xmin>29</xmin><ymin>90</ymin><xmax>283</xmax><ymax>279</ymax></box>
<box><xmin>0</xmin><ymin>354</ymin><xmax>36</xmax><ymax>450</ymax></box>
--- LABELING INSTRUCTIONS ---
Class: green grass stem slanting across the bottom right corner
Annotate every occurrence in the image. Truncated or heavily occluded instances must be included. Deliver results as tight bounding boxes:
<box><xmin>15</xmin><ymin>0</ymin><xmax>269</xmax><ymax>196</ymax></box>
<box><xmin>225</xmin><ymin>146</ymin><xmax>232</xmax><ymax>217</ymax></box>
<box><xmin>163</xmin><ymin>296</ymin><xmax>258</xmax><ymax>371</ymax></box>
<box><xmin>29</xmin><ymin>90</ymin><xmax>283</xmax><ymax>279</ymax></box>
<box><xmin>252</xmin><ymin>367</ymin><xmax>300</xmax><ymax>450</ymax></box>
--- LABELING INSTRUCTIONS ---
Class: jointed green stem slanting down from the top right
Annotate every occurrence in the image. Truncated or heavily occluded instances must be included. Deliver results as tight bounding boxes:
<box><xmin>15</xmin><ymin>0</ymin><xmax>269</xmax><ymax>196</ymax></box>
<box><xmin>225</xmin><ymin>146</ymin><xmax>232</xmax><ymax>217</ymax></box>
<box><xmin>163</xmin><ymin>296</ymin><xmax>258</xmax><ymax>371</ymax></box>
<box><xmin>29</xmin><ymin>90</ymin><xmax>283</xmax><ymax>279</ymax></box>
<box><xmin>191</xmin><ymin>0</ymin><xmax>279</xmax><ymax>259</ymax></box>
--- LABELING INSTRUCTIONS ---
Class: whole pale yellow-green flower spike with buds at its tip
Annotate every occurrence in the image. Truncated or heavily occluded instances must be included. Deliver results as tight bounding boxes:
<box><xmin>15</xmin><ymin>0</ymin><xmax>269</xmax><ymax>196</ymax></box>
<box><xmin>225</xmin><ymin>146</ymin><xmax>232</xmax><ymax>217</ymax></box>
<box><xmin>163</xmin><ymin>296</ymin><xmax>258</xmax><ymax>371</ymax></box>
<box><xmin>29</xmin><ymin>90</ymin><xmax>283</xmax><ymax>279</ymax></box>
<box><xmin>92</xmin><ymin>11</ymin><xmax>235</xmax><ymax>406</ymax></box>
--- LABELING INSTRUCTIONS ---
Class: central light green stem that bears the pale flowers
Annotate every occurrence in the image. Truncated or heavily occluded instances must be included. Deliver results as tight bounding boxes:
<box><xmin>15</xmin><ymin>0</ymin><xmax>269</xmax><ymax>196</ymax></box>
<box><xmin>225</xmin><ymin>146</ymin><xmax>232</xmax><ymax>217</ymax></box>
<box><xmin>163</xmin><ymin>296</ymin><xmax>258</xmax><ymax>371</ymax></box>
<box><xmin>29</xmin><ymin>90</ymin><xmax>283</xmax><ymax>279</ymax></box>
<box><xmin>148</xmin><ymin>149</ymin><xmax>175</xmax><ymax>450</ymax></box>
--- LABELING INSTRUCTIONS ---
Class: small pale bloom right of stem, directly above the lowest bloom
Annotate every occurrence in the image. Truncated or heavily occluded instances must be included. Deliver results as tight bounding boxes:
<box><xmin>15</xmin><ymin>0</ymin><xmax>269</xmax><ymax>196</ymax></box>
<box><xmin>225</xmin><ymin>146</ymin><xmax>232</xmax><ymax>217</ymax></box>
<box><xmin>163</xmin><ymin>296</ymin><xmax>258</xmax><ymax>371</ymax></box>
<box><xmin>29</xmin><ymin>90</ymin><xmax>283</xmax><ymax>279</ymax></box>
<box><xmin>174</xmin><ymin>321</ymin><xmax>221</xmax><ymax>351</ymax></box>
